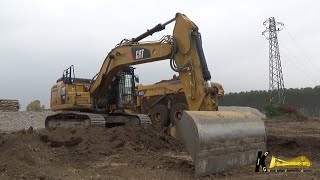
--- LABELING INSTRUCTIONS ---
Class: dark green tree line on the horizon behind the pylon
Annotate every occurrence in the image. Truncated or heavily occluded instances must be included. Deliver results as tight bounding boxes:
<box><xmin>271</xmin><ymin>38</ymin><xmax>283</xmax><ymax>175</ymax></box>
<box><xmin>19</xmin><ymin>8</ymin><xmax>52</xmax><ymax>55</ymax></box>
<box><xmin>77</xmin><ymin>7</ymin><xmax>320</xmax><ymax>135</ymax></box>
<box><xmin>219</xmin><ymin>86</ymin><xmax>320</xmax><ymax>116</ymax></box>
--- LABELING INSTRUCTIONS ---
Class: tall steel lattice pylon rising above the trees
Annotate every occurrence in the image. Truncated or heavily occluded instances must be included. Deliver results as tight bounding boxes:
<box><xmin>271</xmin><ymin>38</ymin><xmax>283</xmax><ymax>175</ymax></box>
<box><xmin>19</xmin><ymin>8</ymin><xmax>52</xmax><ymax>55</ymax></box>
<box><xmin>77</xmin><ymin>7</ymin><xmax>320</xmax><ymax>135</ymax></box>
<box><xmin>262</xmin><ymin>17</ymin><xmax>285</xmax><ymax>103</ymax></box>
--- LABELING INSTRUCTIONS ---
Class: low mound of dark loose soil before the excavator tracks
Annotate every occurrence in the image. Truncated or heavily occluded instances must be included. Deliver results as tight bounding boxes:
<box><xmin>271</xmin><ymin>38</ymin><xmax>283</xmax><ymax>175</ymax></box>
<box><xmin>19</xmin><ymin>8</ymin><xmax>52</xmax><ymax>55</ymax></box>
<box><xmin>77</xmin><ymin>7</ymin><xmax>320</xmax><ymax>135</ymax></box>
<box><xmin>38</xmin><ymin>126</ymin><xmax>182</xmax><ymax>154</ymax></box>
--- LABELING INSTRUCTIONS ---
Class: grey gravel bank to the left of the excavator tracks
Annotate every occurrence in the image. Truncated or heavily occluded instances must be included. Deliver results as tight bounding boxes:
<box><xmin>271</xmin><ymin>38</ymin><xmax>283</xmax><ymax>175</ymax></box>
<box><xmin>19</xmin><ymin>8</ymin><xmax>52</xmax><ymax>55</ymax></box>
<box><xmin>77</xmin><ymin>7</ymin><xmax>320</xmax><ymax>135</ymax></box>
<box><xmin>0</xmin><ymin>111</ymin><xmax>53</xmax><ymax>132</ymax></box>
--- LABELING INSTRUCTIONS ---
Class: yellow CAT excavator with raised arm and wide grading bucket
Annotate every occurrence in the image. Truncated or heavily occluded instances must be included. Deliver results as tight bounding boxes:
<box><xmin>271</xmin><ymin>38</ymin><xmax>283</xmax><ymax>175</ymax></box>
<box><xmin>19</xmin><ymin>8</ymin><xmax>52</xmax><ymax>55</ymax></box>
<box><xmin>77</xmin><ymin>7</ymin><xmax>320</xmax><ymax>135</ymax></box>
<box><xmin>45</xmin><ymin>13</ymin><xmax>266</xmax><ymax>176</ymax></box>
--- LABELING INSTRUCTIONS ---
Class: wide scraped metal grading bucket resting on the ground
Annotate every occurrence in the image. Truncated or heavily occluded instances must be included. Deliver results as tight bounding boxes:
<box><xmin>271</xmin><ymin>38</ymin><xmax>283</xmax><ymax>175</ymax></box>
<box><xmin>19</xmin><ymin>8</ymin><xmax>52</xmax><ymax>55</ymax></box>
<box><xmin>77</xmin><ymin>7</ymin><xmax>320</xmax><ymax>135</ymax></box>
<box><xmin>177</xmin><ymin>111</ymin><xmax>266</xmax><ymax>177</ymax></box>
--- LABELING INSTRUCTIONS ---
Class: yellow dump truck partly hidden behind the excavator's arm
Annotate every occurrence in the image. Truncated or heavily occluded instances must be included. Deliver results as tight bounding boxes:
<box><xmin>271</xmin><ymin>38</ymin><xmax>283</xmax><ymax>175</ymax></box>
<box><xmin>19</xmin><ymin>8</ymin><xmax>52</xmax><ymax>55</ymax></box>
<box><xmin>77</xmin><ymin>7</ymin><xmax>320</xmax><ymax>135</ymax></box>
<box><xmin>137</xmin><ymin>76</ymin><xmax>224</xmax><ymax>126</ymax></box>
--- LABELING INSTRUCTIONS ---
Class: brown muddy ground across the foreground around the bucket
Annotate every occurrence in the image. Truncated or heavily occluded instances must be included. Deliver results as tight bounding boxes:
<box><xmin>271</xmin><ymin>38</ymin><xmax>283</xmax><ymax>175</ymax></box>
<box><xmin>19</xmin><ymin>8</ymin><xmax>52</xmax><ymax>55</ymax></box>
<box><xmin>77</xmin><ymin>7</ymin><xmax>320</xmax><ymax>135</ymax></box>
<box><xmin>0</xmin><ymin>113</ymin><xmax>320</xmax><ymax>179</ymax></box>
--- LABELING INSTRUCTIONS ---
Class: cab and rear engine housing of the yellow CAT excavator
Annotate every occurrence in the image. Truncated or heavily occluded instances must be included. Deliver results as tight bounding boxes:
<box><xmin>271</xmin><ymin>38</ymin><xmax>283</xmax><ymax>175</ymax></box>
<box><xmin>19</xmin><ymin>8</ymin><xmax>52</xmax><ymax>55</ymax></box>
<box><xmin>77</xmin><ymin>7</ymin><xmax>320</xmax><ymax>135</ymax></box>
<box><xmin>50</xmin><ymin>65</ymin><xmax>136</xmax><ymax>111</ymax></box>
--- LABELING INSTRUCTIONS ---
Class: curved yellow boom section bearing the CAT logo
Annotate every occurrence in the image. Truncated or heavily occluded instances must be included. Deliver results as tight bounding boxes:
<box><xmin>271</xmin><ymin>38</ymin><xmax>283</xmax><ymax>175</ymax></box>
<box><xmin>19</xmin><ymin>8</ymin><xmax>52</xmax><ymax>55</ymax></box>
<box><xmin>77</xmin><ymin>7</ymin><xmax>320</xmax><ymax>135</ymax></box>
<box><xmin>90</xmin><ymin>38</ymin><xmax>172</xmax><ymax>103</ymax></box>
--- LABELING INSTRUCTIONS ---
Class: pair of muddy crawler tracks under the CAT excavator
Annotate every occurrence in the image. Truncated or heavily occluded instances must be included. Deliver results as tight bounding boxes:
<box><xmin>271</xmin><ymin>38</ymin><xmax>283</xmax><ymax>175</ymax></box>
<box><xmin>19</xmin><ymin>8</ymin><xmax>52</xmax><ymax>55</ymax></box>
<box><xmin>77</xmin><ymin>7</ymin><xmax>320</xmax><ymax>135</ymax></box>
<box><xmin>45</xmin><ymin>111</ymin><xmax>151</xmax><ymax>129</ymax></box>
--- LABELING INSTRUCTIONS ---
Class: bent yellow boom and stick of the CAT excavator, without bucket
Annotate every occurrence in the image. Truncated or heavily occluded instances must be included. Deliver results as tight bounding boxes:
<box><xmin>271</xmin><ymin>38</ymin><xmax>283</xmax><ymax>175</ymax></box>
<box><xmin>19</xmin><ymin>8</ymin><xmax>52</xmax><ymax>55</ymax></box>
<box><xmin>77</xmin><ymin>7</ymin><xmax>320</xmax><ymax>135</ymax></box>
<box><xmin>90</xmin><ymin>13</ymin><xmax>217</xmax><ymax>111</ymax></box>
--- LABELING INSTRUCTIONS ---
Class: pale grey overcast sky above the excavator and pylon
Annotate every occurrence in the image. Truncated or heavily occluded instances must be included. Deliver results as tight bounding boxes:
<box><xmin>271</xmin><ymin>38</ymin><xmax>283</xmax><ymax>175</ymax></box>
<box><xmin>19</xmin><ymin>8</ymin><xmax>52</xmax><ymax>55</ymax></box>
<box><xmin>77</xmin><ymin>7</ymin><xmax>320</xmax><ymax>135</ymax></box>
<box><xmin>0</xmin><ymin>0</ymin><xmax>320</xmax><ymax>107</ymax></box>
